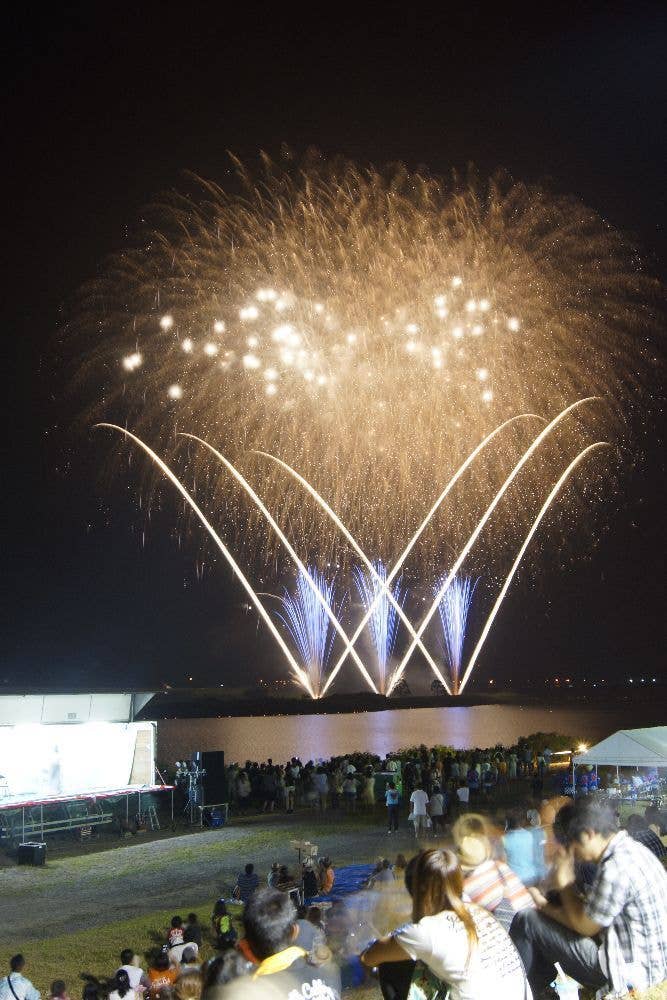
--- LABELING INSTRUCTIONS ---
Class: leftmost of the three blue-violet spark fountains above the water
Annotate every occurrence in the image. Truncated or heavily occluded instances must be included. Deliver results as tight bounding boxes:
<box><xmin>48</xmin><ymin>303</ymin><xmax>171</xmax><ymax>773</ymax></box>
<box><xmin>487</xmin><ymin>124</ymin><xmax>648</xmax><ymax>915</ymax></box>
<box><xmin>276</xmin><ymin>568</ymin><xmax>342</xmax><ymax>698</ymax></box>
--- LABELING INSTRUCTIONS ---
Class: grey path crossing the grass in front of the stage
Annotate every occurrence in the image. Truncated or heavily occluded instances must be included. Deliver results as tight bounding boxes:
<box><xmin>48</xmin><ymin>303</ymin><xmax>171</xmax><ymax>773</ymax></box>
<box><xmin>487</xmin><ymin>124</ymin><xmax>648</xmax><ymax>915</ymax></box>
<box><xmin>0</xmin><ymin>809</ymin><xmax>415</xmax><ymax>941</ymax></box>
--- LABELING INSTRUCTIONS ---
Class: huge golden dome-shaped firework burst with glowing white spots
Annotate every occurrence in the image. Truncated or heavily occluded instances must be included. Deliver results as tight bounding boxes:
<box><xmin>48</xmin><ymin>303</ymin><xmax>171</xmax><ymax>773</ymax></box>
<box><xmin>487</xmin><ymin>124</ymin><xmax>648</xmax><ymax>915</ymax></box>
<box><xmin>83</xmin><ymin>155</ymin><xmax>648</xmax><ymax>574</ymax></box>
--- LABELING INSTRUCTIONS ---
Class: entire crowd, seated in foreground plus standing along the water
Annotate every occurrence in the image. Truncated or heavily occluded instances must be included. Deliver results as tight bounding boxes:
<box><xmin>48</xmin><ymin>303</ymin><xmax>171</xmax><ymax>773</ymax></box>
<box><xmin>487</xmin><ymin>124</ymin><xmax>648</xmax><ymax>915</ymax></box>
<box><xmin>6</xmin><ymin>747</ymin><xmax>667</xmax><ymax>1000</ymax></box>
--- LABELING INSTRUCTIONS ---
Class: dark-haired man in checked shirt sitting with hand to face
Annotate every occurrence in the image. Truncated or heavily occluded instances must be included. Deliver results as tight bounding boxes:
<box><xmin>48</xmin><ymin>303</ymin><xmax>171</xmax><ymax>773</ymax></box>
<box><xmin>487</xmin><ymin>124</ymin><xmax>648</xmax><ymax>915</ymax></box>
<box><xmin>510</xmin><ymin>797</ymin><xmax>667</xmax><ymax>996</ymax></box>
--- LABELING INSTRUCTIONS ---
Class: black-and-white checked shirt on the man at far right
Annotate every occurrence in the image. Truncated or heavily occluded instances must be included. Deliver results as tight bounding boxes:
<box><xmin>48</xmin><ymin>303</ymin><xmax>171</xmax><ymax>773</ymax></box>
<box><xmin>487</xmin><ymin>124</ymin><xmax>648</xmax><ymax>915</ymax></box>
<box><xmin>585</xmin><ymin>830</ymin><xmax>667</xmax><ymax>995</ymax></box>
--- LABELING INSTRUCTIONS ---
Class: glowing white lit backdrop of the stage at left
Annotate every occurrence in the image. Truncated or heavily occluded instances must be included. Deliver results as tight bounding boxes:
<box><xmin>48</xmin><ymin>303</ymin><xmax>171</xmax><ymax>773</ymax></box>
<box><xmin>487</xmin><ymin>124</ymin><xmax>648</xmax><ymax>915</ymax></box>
<box><xmin>0</xmin><ymin>722</ymin><xmax>152</xmax><ymax>799</ymax></box>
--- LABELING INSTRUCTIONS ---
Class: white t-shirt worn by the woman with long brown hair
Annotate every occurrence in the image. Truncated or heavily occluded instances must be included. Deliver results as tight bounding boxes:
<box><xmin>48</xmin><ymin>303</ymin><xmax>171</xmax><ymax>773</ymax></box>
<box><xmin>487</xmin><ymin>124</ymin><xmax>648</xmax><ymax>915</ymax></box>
<box><xmin>394</xmin><ymin>904</ymin><xmax>532</xmax><ymax>1000</ymax></box>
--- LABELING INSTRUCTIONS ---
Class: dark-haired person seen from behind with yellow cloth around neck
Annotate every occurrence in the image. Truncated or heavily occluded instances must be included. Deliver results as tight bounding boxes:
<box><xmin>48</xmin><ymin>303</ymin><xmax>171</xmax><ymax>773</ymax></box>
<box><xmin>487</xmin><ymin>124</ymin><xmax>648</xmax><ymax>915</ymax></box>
<box><xmin>219</xmin><ymin>888</ymin><xmax>341</xmax><ymax>1000</ymax></box>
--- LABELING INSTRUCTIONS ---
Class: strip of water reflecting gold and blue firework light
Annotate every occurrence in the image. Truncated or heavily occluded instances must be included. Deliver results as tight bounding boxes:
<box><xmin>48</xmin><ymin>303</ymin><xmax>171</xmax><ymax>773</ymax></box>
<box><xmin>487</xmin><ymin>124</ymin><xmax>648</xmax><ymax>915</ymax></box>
<box><xmin>158</xmin><ymin>705</ymin><xmax>641</xmax><ymax>763</ymax></box>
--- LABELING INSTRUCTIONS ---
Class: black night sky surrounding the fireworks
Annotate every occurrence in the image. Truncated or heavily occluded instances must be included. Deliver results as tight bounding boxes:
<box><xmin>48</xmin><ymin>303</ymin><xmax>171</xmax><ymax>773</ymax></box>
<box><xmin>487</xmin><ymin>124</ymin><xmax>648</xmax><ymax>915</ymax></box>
<box><xmin>0</xmin><ymin>3</ymin><xmax>667</xmax><ymax>689</ymax></box>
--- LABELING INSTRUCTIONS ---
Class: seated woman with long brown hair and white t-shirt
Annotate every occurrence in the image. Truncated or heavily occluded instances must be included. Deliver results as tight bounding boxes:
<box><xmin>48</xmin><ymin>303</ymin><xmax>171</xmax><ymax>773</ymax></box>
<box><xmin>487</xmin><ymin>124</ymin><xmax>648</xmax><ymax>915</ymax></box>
<box><xmin>361</xmin><ymin>851</ymin><xmax>532</xmax><ymax>1000</ymax></box>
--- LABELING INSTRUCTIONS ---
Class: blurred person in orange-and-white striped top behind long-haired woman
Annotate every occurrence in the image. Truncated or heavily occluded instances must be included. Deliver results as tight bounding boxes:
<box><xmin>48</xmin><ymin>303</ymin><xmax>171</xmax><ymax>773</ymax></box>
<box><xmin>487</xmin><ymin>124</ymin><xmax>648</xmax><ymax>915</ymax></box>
<box><xmin>456</xmin><ymin>834</ymin><xmax>535</xmax><ymax>930</ymax></box>
